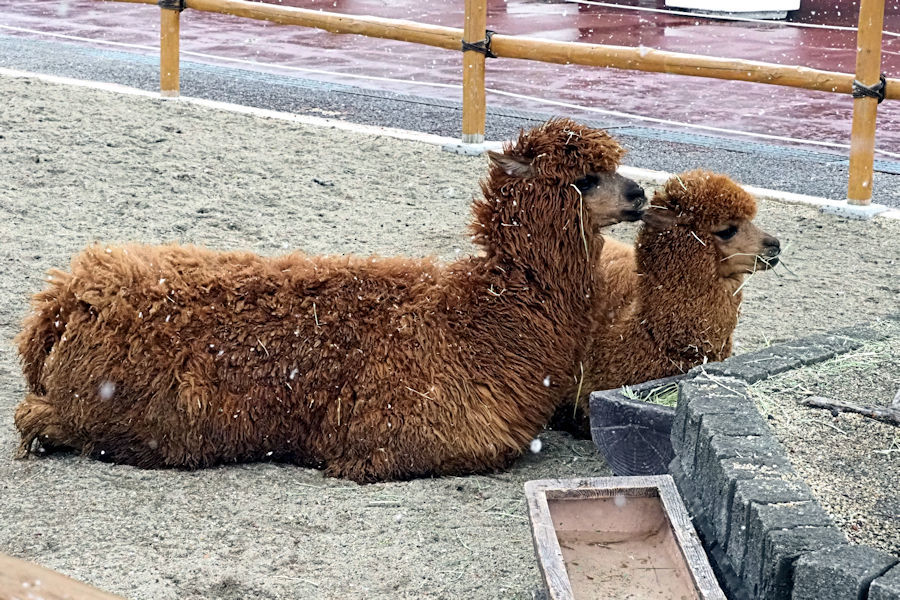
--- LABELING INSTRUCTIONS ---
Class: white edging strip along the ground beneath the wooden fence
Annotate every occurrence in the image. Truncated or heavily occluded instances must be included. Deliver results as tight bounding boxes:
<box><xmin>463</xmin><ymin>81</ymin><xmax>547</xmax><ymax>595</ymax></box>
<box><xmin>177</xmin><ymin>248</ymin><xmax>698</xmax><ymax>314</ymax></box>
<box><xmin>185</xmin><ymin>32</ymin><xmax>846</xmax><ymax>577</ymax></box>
<box><xmin>0</xmin><ymin>67</ymin><xmax>900</xmax><ymax>219</ymax></box>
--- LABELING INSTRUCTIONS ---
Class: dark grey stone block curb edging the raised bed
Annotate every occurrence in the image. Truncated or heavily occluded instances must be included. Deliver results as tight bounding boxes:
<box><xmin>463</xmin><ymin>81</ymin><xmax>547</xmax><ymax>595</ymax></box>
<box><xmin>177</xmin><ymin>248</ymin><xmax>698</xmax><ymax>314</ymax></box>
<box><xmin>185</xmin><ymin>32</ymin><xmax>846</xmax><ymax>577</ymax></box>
<box><xmin>669</xmin><ymin>316</ymin><xmax>900</xmax><ymax>600</ymax></box>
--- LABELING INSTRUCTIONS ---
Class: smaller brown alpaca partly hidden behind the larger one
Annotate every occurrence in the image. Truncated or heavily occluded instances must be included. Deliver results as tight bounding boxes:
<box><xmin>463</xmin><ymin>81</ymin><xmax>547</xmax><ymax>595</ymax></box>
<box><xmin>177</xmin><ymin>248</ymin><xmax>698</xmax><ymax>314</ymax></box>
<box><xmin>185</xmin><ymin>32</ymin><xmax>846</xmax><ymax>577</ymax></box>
<box><xmin>557</xmin><ymin>170</ymin><xmax>780</xmax><ymax>433</ymax></box>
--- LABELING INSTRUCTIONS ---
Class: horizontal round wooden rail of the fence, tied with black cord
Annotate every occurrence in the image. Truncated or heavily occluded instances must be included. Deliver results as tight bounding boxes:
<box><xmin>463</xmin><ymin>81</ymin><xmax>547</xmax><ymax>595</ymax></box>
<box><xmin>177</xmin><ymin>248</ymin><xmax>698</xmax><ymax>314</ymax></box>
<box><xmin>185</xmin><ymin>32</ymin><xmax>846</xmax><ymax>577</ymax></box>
<box><xmin>148</xmin><ymin>0</ymin><xmax>900</xmax><ymax>100</ymax></box>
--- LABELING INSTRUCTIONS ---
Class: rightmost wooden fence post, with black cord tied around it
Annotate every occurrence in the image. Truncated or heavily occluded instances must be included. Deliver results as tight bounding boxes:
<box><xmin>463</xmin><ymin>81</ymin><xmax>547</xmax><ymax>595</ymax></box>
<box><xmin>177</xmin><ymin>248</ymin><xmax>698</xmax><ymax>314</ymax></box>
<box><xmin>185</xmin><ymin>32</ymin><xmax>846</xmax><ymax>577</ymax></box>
<box><xmin>847</xmin><ymin>0</ymin><xmax>884</xmax><ymax>205</ymax></box>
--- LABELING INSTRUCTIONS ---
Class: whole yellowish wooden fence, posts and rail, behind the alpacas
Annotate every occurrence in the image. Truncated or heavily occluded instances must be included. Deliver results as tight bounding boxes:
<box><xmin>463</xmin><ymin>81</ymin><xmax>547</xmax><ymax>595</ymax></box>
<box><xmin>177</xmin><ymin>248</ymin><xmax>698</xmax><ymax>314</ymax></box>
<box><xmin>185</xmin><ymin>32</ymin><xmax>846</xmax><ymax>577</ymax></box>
<box><xmin>105</xmin><ymin>0</ymin><xmax>900</xmax><ymax>205</ymax></box>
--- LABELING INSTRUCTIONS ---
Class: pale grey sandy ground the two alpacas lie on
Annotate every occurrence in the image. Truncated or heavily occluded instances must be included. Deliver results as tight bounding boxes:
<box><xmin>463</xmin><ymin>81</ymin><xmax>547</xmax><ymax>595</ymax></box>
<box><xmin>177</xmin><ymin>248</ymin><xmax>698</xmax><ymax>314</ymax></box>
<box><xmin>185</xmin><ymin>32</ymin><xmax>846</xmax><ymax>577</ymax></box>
<box><xmin>0</xmin><ymin>78</ymin><xmax>900</xmax><ymax>600</ymax></box>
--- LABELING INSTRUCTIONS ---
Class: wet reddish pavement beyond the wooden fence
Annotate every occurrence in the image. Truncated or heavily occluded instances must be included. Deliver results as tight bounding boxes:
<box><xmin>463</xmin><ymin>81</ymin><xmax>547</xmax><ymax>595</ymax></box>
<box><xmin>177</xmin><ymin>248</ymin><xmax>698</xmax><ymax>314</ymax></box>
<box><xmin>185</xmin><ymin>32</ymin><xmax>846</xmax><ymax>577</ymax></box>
<box><xmin>0</xmin><ymin>0</ymin><xmax>900</xmax><ymax>153</ymax></box>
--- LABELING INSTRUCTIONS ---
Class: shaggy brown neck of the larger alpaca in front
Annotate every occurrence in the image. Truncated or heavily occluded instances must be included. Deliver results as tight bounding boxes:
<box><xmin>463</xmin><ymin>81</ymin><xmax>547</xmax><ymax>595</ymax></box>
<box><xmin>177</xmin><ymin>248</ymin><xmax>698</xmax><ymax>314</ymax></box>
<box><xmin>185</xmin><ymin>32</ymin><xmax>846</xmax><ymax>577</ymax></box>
<box><xmin>458</xmin><ymin>177</ymin><xmax>603</xmax><ymax>414</ymax></box>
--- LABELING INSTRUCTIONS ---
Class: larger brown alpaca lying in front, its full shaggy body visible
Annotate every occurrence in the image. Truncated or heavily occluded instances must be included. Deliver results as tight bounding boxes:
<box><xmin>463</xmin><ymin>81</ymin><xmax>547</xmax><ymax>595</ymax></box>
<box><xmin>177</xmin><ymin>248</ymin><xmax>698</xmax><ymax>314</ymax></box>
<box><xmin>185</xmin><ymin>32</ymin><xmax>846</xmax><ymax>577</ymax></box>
<box><xmin>15</xmin><ymin>120</ymin><xmax>645</xmax><ymax>482</ymax></box>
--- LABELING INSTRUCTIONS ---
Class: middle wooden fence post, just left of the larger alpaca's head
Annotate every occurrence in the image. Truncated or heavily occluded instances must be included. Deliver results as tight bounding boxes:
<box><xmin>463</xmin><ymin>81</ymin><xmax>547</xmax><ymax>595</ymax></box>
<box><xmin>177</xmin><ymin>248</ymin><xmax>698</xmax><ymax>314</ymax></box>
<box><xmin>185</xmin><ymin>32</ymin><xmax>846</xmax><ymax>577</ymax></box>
<box><xmin>462</xmin><ymin>0</ymin><xmax>487</xmax><ymax>144</ymax></box>
